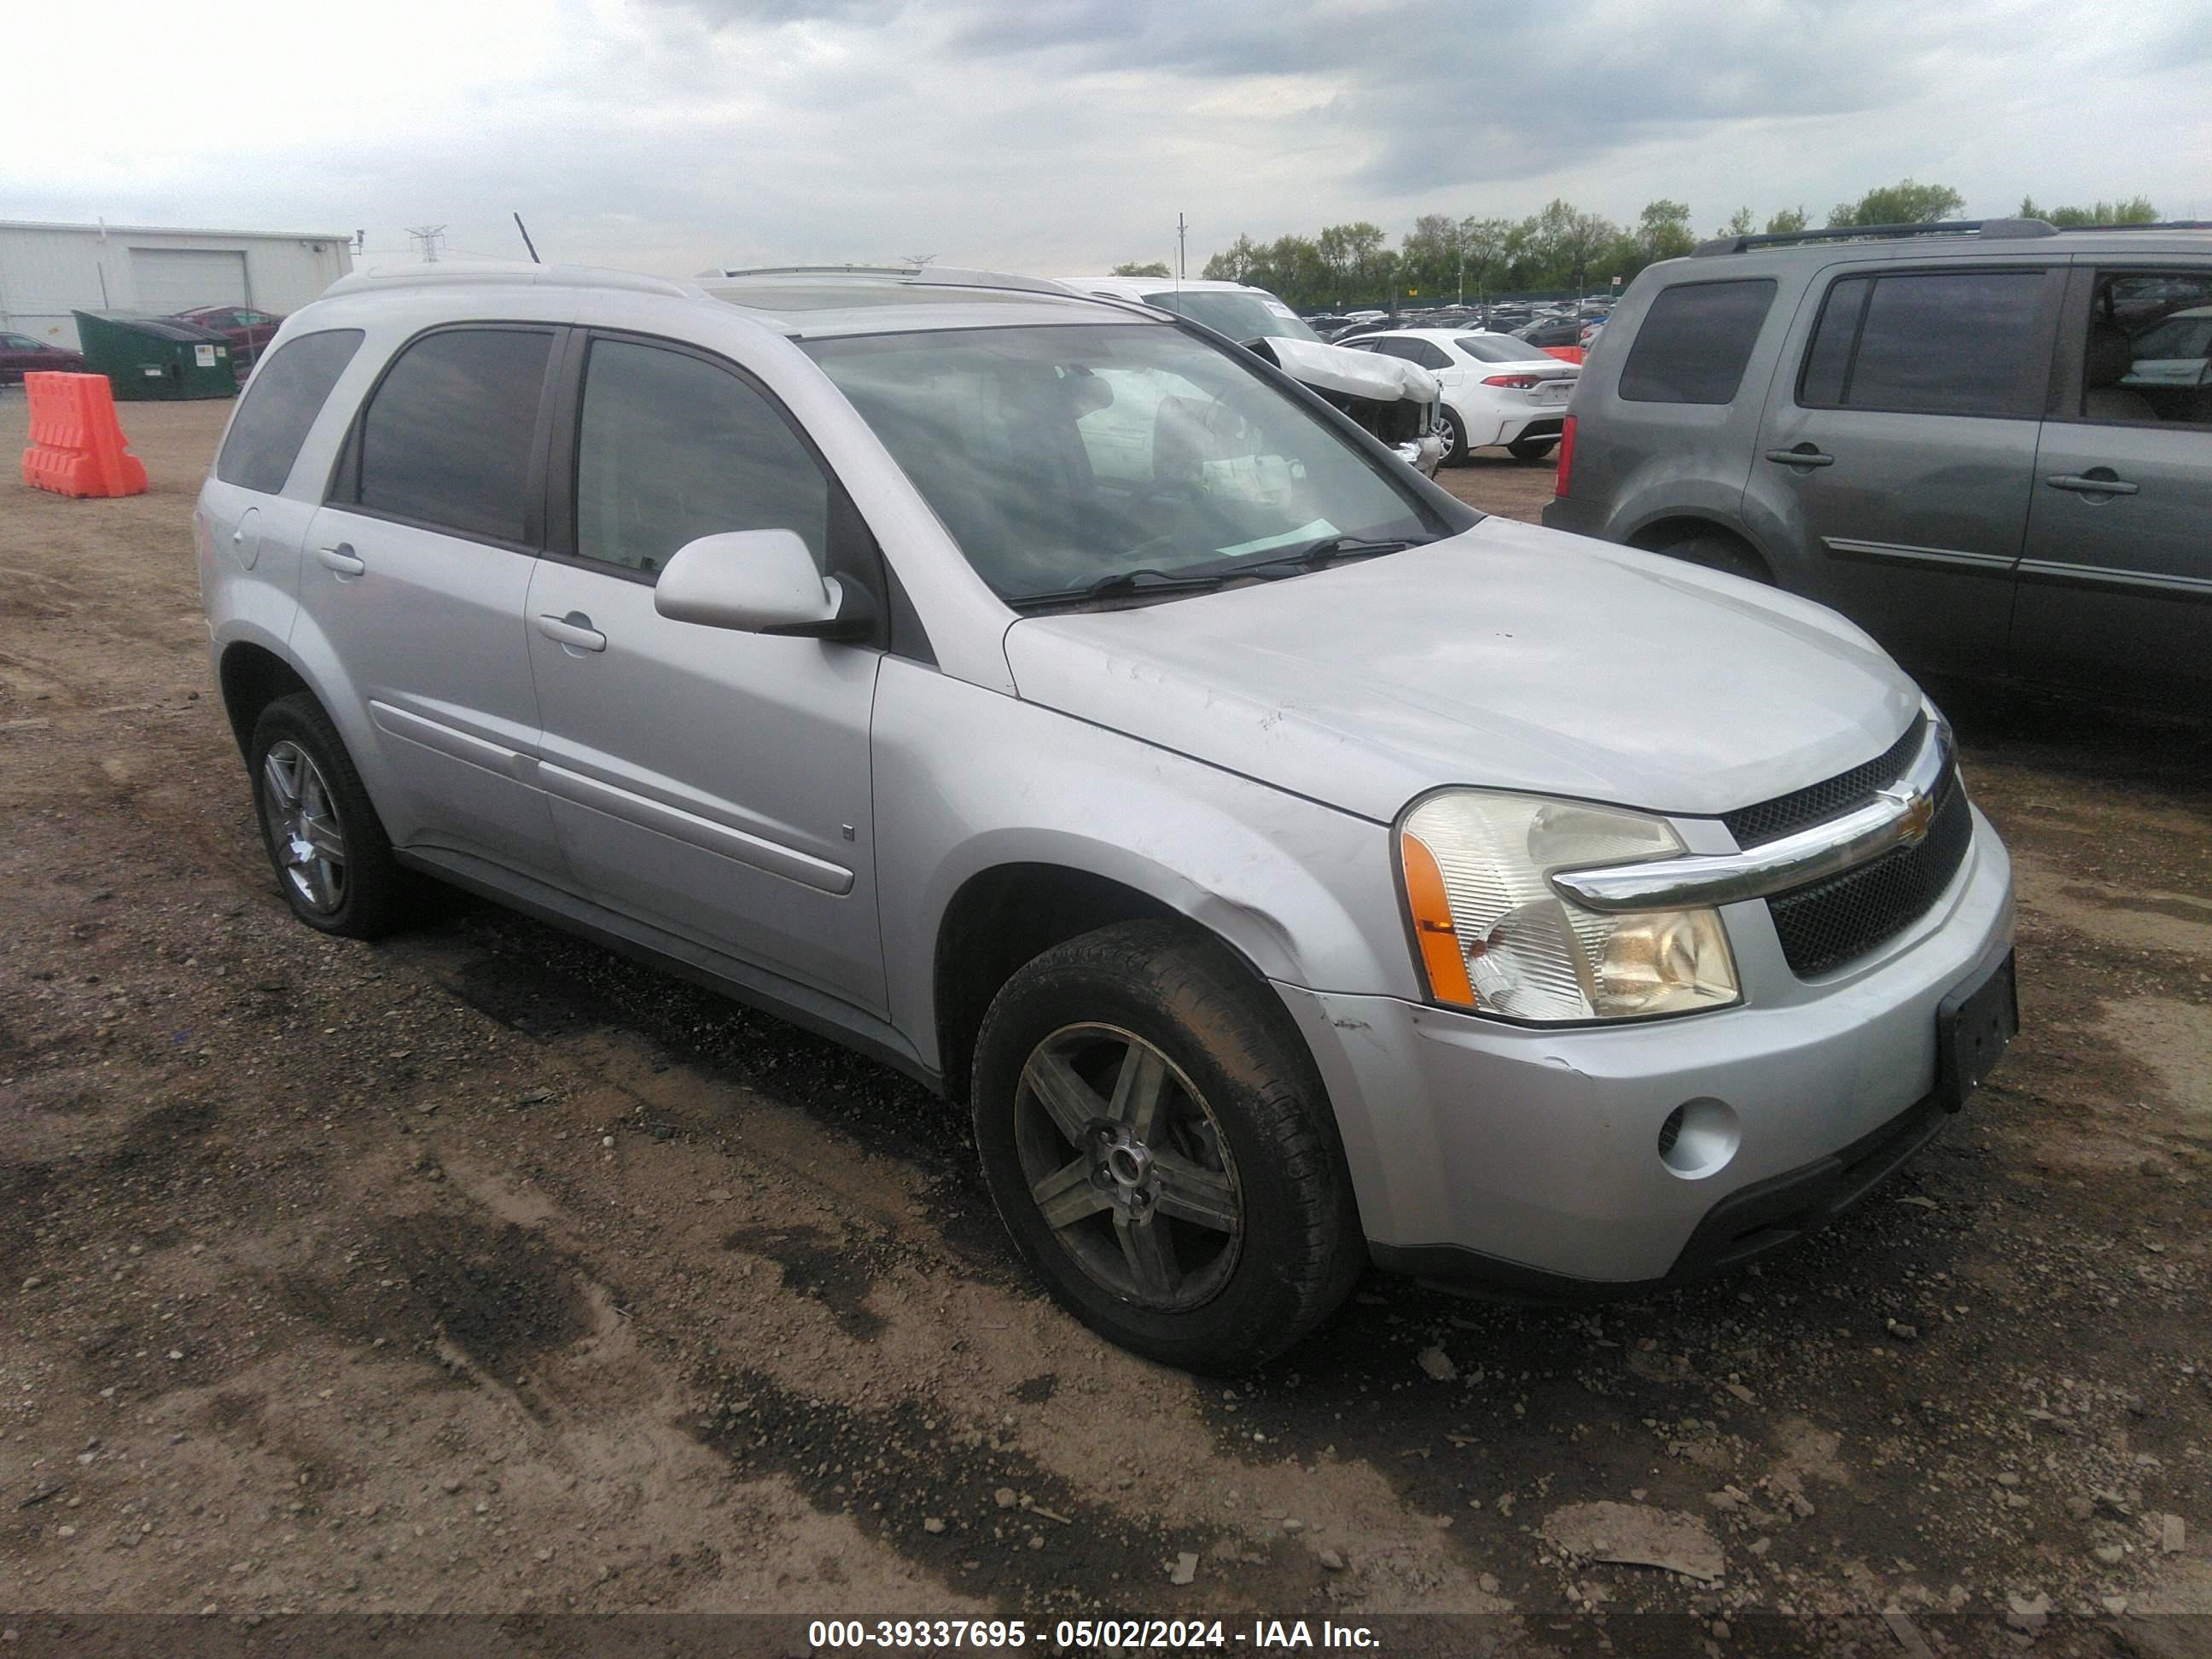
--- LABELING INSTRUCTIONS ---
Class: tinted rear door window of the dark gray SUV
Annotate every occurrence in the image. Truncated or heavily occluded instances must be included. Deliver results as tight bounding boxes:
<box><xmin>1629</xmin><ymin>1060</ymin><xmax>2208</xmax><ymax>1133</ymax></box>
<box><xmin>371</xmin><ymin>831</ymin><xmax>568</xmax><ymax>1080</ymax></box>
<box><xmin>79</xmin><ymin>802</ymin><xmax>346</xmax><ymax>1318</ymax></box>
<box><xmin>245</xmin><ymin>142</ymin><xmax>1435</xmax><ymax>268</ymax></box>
<box><xmin>1798</xmin><ymin>270</ymin><xmax>2048</xmax><ymax>416</ymax></box>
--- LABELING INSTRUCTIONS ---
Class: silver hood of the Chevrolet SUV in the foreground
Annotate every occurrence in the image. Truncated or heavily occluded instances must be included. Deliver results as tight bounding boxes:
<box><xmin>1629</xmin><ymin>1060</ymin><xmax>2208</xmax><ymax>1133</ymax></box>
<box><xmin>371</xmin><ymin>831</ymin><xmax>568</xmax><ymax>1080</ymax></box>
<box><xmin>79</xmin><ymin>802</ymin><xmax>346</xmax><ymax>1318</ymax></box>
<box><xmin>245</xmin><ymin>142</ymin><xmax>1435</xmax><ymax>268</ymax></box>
<box><xmin>1006</xmin><ymin>518</ymin><xmax>1920</xmax><ymax>821</ymax></box>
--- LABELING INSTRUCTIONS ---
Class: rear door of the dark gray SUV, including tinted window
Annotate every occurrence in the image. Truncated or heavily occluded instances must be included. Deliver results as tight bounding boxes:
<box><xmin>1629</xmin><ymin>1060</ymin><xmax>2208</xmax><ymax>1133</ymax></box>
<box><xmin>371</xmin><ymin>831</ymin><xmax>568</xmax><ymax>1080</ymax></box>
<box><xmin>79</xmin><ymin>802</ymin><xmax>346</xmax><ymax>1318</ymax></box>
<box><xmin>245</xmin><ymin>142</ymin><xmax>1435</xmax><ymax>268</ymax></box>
<box><xmin>1745</xmin><ymin>261</ymin><xmax>2066</xmax><ymax>675</ymax></box>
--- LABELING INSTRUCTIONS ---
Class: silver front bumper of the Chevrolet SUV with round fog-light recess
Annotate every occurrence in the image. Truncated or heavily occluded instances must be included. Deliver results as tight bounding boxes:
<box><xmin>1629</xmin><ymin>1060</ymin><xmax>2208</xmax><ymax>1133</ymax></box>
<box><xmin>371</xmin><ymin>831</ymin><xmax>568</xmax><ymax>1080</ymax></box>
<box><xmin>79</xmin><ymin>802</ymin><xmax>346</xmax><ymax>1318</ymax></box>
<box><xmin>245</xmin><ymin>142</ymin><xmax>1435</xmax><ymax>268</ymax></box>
<box><xmin>1278</xmin><ymin>814</ymin><xmax>2013</xmax><ymax>1296</ymax></box>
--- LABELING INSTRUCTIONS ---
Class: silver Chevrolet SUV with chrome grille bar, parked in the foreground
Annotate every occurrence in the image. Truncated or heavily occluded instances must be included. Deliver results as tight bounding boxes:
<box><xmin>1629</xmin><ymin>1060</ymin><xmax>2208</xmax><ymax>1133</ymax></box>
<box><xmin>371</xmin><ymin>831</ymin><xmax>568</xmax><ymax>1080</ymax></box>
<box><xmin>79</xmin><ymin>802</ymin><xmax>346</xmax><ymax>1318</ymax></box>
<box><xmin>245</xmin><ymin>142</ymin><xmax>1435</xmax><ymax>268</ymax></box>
<box><xmin>195</xmin><ymin>268</ymin><xmax>2015</xmax><ymax>1369</ymax></box>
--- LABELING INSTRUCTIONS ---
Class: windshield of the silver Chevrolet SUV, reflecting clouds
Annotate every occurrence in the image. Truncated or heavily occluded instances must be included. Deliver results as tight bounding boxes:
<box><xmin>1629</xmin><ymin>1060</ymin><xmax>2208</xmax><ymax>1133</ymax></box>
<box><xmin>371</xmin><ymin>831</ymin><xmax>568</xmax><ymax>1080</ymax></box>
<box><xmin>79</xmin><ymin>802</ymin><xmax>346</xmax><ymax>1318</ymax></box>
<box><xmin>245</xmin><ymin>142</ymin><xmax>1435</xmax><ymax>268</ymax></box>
<box><xmin>803</xmin><ymin>323</ymin><xmax>1442</xmax><ymax>604</ymax></box>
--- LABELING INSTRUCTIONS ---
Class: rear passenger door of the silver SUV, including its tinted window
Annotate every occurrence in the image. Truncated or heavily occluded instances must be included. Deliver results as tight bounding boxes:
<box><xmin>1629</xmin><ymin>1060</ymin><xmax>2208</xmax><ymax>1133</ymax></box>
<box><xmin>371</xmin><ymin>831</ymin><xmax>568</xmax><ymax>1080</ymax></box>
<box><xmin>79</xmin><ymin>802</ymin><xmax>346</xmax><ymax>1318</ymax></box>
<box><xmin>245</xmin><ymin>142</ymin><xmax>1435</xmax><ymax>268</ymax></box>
<box><xmin>296</xmin><ymin>323</ymin><xmax>567</xmax><ymax>885</ymax></box>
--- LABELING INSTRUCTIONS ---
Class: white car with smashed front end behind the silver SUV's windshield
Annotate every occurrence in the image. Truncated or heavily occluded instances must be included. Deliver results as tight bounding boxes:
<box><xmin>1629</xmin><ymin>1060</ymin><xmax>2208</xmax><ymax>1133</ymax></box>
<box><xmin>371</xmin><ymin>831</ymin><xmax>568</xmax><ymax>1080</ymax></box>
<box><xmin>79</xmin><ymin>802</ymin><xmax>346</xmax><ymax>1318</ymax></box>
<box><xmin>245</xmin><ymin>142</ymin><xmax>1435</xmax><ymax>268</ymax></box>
<box><xmin>1053</xmin><ymin>276</ymin><xmax>1449</xmax><ymax>478</ymax></box>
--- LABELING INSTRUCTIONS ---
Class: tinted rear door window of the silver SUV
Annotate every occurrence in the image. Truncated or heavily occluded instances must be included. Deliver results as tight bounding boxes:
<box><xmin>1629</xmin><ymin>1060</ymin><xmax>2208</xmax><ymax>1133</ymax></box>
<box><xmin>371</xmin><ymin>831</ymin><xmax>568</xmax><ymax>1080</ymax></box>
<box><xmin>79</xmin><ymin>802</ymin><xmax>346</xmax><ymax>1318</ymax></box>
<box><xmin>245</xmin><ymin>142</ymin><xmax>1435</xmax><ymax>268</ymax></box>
<box><xmin>356</xmin><ymin>328</ymin><xmax>553</xmax><ymax>542</ymax></box>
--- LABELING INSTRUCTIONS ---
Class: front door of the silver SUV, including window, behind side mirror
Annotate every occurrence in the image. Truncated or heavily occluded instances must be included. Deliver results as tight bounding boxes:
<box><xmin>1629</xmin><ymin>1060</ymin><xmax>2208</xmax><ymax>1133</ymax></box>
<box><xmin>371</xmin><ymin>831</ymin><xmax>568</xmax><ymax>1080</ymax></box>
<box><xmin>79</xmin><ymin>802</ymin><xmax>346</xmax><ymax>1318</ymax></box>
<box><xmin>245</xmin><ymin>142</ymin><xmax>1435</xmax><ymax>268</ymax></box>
<box><xmin>528</xmin><ymin>334</ymin><xmax>885</xmax><ymax>1013</ymax></box>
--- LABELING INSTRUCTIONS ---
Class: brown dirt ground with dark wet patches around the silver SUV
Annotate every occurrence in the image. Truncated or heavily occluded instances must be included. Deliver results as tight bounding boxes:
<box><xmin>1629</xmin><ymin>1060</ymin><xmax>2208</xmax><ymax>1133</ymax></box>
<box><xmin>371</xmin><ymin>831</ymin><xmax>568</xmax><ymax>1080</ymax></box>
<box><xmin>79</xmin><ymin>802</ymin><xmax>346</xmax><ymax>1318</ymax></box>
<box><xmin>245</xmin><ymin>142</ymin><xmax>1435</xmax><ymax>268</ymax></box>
<box><xmin>0</xmin><ymin>392</ymin><xmax>2212</xmax><ymax>1652</ymax></box>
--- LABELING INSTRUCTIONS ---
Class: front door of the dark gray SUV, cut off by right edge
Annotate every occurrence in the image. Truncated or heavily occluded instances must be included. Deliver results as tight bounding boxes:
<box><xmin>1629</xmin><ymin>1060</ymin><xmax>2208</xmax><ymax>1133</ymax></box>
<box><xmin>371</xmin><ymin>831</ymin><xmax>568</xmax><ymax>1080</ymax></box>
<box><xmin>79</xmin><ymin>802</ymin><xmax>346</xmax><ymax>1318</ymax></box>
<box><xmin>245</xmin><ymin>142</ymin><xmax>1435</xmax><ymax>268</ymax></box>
<box><xmin>2013</xmin><ymin>261</ymin><xmax>2212</xmax><ymax>710</ymax></box>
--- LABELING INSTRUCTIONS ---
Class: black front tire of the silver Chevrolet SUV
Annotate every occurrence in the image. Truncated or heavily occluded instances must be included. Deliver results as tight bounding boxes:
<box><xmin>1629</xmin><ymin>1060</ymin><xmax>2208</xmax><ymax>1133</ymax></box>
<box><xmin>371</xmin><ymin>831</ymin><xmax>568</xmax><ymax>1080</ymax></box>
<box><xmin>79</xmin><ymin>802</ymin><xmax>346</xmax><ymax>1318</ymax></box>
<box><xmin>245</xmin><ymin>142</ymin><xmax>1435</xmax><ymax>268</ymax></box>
<box><xmin>973</xmin><ymin>923</ymin><xmax>1367</xmax><ymax>1374</ymax></box>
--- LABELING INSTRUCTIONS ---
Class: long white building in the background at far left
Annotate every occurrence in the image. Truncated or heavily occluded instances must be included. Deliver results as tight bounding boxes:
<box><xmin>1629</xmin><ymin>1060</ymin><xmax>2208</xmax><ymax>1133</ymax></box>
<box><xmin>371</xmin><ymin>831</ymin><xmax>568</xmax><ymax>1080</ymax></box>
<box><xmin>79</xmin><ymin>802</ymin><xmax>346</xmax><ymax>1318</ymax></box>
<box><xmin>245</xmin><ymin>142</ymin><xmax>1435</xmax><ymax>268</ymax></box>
<box><xmin>0</xmin><ymin>219</ymin><xmax>354</xmax><ymax>350</ymax></box>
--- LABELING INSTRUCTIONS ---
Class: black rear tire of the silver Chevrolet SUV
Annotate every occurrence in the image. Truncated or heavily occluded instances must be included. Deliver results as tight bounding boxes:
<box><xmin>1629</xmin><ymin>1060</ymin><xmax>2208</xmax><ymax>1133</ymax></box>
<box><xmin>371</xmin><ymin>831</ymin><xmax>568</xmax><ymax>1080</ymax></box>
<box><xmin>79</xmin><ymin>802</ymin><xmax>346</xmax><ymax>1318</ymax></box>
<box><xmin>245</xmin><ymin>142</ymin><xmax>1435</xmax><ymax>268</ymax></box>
<box><xmin>246</xmin><ymin>692</ymin><xmax>410</xmax><ymax>938</ymax></box>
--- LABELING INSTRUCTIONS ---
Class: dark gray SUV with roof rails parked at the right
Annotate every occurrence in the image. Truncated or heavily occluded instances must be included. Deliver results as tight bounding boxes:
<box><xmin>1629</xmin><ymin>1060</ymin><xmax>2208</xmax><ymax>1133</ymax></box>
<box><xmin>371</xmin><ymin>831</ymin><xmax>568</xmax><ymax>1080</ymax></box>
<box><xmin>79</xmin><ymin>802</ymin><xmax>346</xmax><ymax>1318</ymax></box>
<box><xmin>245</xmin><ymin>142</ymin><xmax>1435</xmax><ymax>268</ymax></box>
<box><xmin>1544</xmin><ymin>219</ymin><xmax>2212</xmax><ymax>713</ymax></box>
